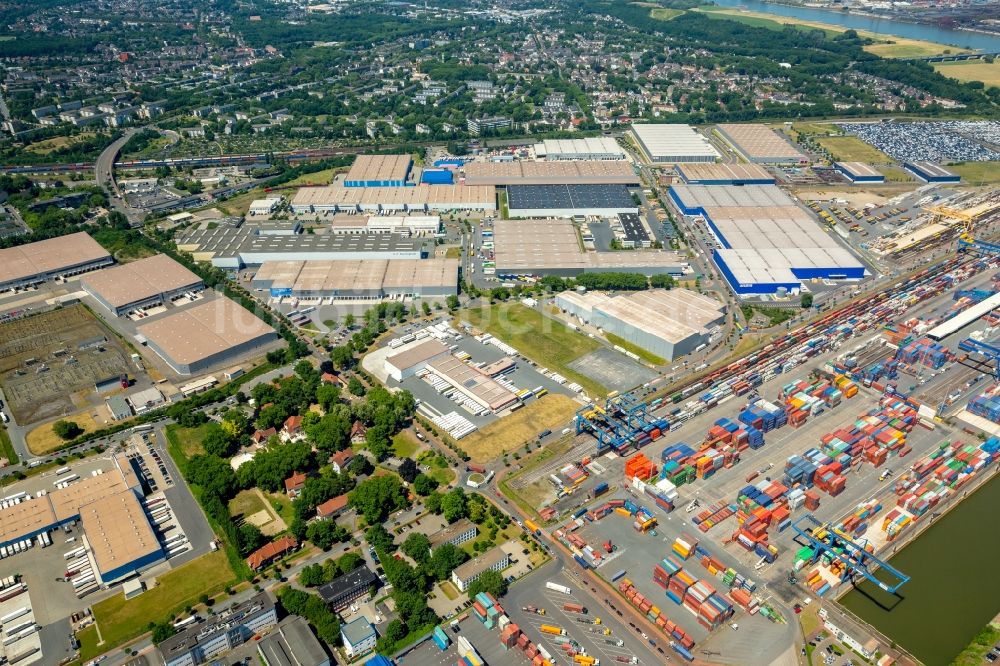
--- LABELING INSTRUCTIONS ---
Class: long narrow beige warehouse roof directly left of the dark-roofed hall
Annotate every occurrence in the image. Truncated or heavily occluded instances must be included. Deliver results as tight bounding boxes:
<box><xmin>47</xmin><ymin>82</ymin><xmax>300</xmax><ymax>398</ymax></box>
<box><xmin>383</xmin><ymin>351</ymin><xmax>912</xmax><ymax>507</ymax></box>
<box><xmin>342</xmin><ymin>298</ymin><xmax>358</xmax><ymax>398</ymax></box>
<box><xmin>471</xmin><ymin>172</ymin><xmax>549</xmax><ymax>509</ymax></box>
<box><xmin>292</xmin><ymin>185</ymin><xmax>496</xmax><ymax>209</ymax></box>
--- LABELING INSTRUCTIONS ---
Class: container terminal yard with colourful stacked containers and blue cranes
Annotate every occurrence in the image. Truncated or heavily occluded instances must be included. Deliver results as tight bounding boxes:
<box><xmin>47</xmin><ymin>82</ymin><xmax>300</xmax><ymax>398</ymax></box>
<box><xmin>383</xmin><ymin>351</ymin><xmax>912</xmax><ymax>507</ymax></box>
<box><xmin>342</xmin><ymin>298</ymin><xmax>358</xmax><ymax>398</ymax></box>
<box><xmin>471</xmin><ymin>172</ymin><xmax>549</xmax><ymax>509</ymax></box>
<box><xmin>488</xmin><ymin>246</ymin><xmax>1000</xmax><ymax>664</ymax></box>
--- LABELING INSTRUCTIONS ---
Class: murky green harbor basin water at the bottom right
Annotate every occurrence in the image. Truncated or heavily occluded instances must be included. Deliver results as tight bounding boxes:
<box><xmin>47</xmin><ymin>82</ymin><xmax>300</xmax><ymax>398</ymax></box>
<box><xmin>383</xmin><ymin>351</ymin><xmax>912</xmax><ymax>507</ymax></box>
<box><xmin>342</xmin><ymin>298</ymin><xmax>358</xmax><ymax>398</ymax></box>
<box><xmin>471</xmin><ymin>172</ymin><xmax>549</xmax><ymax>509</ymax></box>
<box><xmin>841</xmin><ymin>476</ymin><xmax>1000</xmax><ymax>666</ymax></box>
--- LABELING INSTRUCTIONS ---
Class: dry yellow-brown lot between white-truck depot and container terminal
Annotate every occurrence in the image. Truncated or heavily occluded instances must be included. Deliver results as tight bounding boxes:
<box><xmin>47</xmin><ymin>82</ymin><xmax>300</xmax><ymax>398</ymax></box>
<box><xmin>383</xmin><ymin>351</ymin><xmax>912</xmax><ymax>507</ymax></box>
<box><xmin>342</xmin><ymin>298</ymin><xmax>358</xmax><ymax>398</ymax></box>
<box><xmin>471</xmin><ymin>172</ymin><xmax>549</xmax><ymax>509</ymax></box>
<box><xmin>461</xmin><ymin>393</ymin><xmax>579</xmax><ymax>462</ymax></box>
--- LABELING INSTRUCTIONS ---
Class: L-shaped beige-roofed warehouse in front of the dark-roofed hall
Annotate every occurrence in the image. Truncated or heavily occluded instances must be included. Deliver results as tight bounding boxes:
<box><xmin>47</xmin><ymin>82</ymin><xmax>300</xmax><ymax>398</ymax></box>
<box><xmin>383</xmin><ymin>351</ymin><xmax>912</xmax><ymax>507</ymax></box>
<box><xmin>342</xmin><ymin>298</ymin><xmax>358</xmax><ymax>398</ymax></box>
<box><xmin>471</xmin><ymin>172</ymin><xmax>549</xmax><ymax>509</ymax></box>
<box><xmin>493</xmin><ymin>219</ymin><xmax>690</xmax><ymax>277</ymax></box>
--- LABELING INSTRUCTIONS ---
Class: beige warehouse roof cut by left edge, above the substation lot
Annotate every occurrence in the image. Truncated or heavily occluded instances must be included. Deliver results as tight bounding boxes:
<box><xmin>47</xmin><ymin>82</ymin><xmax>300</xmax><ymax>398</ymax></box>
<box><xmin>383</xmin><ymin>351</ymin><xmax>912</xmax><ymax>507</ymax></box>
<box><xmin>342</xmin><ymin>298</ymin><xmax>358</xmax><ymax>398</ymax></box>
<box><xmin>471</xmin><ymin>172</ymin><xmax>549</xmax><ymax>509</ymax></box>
<box><xmin>0</xmin><ymin>231</ymin><xmax>111</xmax><ymax>284</ymax></box>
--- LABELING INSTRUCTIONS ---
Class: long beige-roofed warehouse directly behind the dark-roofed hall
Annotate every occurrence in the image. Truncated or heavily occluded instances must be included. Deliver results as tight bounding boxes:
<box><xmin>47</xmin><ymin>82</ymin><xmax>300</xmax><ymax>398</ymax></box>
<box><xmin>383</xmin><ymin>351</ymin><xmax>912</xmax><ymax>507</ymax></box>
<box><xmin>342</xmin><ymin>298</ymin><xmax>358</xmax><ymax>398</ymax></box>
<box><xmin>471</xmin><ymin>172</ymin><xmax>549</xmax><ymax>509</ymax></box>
<box><xmin>464</xmin><ymin>160</ymin><xmax>640</xmax><ymax>187</ymax></box>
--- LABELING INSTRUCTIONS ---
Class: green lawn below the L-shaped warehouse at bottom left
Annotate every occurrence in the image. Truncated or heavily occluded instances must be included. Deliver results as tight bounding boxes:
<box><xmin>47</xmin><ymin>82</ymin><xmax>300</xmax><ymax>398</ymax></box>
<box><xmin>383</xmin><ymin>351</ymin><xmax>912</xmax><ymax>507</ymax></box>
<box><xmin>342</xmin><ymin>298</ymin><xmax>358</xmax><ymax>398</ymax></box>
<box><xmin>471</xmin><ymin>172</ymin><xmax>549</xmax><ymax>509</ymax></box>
<box><xmin>80</xmin><ymin>551</ymin><xmax>236</xmax><ymax>660</ymax></box>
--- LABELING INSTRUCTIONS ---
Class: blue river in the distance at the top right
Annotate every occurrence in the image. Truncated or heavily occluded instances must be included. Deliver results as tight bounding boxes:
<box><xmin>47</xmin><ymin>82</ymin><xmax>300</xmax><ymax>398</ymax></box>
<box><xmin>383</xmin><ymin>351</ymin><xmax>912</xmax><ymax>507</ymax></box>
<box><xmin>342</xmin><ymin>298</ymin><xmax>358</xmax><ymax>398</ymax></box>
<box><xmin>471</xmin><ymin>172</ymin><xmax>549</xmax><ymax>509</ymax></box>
<box><xmin>714</xmin><ymin>0</ymin><xmax>1000</xmax><ymax>52</ymax></box>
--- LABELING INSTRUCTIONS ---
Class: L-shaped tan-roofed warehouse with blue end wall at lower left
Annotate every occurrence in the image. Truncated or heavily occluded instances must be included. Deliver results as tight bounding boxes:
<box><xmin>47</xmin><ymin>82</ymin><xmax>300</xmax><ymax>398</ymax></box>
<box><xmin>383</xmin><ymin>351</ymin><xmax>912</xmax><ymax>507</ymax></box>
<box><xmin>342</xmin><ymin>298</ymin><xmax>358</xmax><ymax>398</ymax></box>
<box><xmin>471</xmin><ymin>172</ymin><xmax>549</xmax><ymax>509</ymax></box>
<box><xmin>0</xmin><ymin>455</ymin><xmax>165</xmax><ymax>586</ymax></box>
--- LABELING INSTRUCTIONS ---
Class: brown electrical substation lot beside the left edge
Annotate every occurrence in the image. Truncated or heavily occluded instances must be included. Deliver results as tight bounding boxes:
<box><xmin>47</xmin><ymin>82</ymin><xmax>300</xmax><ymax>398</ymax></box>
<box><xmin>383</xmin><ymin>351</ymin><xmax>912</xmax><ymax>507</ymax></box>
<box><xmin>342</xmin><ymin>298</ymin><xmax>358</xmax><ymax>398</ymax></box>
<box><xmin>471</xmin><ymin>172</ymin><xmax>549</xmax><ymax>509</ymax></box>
<box><xmin>0</xmin><ymin>305</ymin><xmax>135</xmax><ymax>424</ymax></box>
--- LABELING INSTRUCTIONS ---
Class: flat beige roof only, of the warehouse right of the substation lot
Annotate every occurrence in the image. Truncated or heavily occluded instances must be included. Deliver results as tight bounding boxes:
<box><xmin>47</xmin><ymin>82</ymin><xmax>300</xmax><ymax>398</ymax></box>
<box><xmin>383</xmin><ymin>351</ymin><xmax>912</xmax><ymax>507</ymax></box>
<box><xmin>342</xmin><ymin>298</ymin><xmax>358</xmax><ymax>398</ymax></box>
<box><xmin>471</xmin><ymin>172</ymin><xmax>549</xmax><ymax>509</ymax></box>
<box><xmin>138</xmin><ymin>296</ymin><xmax>274</xmax><ymax>364</ymax></box>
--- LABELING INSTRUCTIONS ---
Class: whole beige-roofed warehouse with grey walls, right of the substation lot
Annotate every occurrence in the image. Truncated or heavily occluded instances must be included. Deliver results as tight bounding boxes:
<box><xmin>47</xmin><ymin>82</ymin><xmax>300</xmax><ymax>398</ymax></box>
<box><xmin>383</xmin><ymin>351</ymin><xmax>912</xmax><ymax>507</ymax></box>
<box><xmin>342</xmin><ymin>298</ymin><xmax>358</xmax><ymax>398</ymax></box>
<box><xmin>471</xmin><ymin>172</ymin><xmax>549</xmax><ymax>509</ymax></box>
<box><xmin>136</xmin><ymin>296</ymin><xmax>278</xmax><ymax>375</ymax></box>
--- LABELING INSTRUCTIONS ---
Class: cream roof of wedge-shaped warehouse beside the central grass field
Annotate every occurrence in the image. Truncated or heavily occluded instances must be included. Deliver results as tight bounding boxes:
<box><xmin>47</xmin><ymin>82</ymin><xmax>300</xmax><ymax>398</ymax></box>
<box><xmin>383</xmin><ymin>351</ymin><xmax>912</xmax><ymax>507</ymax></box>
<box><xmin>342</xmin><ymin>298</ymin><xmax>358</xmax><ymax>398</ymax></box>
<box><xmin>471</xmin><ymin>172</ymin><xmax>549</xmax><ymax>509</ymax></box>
<box><xmin>559</xmin><ymin>289</ymin><xmax>725</xmax><ymax>344</ymax></box>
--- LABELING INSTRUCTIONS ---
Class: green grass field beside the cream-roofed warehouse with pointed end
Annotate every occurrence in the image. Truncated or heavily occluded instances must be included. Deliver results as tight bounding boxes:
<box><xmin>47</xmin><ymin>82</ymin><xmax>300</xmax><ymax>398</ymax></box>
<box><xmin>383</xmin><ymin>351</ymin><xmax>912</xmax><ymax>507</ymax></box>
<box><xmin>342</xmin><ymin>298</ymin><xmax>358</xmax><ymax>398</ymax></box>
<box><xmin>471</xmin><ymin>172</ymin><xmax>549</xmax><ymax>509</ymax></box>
<box><xmin>462</xmin><ymin>303</ymin><xmax>608</xmax><ymax>396</ymax></box>
